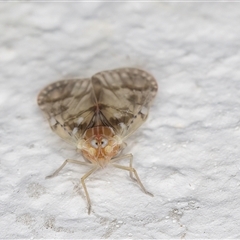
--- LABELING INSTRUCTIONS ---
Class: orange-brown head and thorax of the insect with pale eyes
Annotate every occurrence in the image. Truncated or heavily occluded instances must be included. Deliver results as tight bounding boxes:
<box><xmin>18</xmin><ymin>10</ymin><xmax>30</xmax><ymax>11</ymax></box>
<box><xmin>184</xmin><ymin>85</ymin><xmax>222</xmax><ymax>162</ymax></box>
<box><xmin>77</xmin><ymin>126</ymin><xmax>122</xmax><ymax>167</ymax></box>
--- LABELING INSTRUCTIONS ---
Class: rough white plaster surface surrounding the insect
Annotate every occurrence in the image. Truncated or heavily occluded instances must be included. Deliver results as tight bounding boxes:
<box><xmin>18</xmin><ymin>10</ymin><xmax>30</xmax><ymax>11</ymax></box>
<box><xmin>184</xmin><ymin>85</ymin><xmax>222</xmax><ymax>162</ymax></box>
<box><xmin>0</xmin><ymin>2</ymin><xmax>240</xmax><ymax>239</ymax></box>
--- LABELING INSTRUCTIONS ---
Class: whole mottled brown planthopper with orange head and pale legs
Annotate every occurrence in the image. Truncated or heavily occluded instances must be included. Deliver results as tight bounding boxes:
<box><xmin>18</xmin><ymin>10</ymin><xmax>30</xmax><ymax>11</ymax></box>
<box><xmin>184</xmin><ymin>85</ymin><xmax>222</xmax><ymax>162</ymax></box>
<box><xmin>37</xmin><ymin>68</ymin><xmax>158</xmax><ymax>214</ymax></box>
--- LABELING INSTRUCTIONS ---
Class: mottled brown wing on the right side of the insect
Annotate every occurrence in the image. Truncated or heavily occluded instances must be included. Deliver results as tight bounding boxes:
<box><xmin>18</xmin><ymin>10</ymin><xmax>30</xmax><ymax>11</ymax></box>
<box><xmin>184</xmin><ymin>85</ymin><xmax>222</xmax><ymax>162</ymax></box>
<box><xmin>92</xmin><ymin>68</ymin><xmax>158</xmax><ymax>139</ymax></box>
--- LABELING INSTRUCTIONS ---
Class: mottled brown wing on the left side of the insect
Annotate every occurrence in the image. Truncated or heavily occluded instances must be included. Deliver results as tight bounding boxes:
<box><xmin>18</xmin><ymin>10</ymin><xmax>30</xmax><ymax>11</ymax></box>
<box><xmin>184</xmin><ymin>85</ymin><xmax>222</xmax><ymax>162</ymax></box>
<box><xmin>38</xmin><ymin>79</ymin><xmax>96</xmax><ymax>143</ymax></box>
